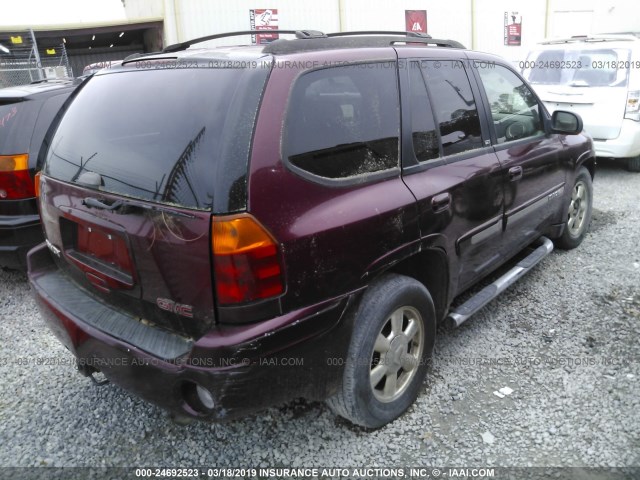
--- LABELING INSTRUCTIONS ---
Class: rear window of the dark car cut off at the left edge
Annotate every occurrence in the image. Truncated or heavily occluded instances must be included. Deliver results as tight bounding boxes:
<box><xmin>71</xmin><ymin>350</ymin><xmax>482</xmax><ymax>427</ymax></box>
<box><xmin>0</xmin><ymin>100</ymin><xmax>40</xmax><ymax>155</ymax></box>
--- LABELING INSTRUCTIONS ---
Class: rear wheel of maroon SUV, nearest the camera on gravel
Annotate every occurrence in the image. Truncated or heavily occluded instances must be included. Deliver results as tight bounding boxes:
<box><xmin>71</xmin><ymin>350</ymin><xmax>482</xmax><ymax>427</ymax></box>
<box><xmin>327</xmin><ymin>274</ymin><xmax>436</xmax><ymax>428</ymax></box>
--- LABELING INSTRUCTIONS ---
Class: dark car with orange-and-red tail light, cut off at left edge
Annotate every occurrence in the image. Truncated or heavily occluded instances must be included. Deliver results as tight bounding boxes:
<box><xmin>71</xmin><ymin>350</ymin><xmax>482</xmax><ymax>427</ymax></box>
<box><xmin>0</xmin><ymin>80</ymin><xmax>76</xmax><ymax>269</ymax></box>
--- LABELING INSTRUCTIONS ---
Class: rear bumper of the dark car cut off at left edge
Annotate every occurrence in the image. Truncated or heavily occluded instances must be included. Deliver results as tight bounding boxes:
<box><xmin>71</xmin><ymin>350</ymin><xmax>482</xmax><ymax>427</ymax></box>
<box><xmin>0</xmin><ymin>215</ymin><xmax>44</xmax><ymax>270</ymax></box>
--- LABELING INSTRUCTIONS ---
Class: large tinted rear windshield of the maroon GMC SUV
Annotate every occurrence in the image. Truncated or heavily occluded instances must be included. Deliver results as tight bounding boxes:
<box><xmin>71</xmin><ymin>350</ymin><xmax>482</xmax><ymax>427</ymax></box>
<box><xmin>45</xmin><ymin>68</ymin><xmax>268</xmax><ymax>210</ymax></box>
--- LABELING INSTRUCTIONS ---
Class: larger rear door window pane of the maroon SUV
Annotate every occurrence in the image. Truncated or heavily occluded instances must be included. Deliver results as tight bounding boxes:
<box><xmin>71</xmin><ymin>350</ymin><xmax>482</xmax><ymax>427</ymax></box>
<box><xmin>421</xmin><ymin>60</ymin><xmax>482</xmax><ymax>155</ymax></box>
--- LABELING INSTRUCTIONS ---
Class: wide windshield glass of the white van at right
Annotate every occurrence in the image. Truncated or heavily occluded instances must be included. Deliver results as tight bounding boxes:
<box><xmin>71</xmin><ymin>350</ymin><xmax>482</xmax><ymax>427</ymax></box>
<box><xmin>522</xmin><ymin>48</ymin><xmax>631</xmax><ymax>87</ymax></box>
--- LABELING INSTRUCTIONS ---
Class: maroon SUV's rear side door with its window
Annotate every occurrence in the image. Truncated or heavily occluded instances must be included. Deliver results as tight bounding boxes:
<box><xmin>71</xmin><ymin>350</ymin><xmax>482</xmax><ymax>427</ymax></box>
<box><xmin>401</xmin><ymin>54</ymin><xmax>504</xmax><ymax>291</ymax></box>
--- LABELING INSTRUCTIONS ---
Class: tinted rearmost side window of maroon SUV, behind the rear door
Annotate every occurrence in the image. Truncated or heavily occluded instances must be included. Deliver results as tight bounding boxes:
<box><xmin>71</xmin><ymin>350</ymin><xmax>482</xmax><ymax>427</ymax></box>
<box><xmin>283</xmin><ymin>62</ymin><xmax>400</xmax><ymax>179</ymax></box>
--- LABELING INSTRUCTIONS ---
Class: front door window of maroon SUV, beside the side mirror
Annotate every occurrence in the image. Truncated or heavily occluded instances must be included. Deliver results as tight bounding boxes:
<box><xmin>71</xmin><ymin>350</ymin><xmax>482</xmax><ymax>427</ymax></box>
<box><xmin>478</xmin><ymin>65</ymin><xmax>544</xmax><ymax>143</ymax></box>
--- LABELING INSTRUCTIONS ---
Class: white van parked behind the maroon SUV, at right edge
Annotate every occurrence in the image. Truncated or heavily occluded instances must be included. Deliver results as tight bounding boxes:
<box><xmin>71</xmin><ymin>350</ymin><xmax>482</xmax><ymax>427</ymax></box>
<box><xmin>521</xmin><ymin>34</ymin><xmax>640</xmax><ymax>172</ymax></box>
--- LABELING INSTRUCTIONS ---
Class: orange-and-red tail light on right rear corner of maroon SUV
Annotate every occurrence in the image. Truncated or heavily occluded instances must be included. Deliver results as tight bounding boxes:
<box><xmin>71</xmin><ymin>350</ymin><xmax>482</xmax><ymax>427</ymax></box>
<box><xmin>211</xmin><ymin>215</ymin><xmax>284</xmax><ymax>305</ymax></box>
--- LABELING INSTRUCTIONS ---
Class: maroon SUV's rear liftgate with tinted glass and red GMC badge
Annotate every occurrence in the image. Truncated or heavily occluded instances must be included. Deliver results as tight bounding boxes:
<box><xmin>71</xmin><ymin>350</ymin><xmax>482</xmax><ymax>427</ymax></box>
<box><xmin>40</xmin><ymin>59</ymin><xmax>269</xmax><ymax>338</ymax></box>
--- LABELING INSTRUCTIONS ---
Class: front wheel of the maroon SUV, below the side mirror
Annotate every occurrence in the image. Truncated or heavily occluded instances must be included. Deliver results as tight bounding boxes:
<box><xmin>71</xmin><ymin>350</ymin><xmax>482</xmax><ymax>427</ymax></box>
<box><xmin>556</xmin><ymin>167</ymin><xmax>593</xmax><ymax>250</ymax></box>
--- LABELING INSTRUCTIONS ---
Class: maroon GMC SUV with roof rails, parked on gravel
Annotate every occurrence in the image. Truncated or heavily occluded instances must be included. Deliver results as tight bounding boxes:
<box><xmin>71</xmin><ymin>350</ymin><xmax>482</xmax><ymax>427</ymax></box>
<box><xmin>29</xmin><ymin>31</ymin><xmax>595</xmax><ymax>428</ymax></box>
